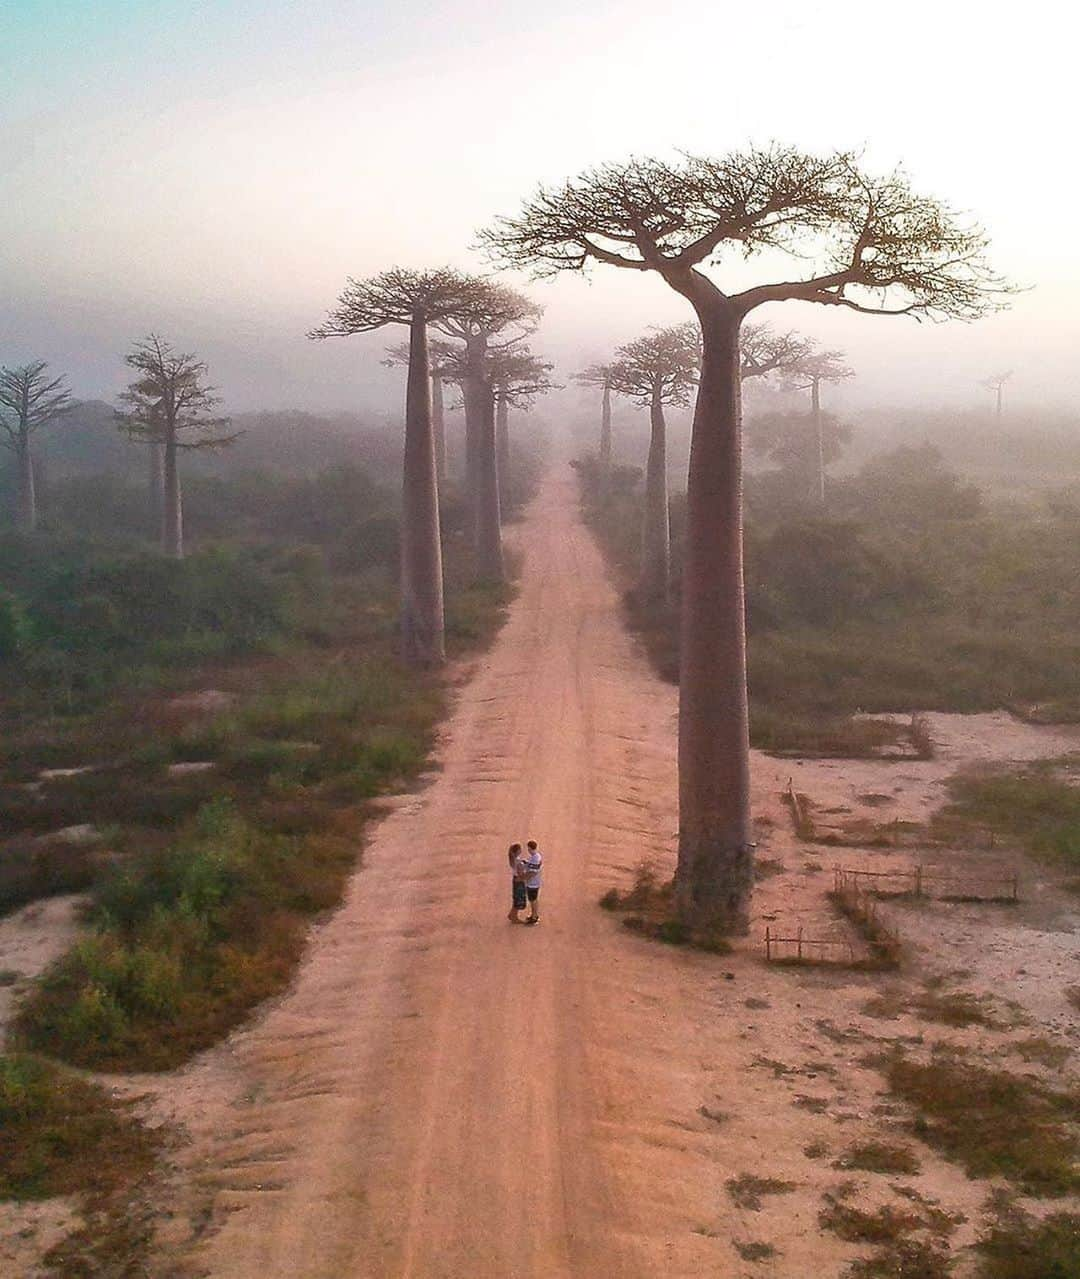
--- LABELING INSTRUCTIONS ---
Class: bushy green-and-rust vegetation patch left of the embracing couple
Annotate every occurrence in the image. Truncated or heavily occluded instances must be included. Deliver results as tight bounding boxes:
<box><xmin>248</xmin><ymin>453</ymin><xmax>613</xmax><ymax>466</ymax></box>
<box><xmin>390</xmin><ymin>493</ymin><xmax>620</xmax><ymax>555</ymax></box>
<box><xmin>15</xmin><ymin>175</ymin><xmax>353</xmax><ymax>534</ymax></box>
<box><xmin>15</xmin><ymin>799</ymin><xmax>354</xmax><ymax>1071</ymax></box>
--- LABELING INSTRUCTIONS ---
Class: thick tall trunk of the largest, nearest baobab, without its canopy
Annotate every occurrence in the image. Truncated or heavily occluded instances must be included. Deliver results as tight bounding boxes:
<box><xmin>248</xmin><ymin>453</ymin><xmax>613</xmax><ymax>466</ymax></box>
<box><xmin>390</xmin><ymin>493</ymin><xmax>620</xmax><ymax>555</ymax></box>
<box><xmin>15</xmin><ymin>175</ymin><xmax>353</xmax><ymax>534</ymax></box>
<box><xmin>676</xmin><ymin>298</ymin><xmax>754</xmax><ymax>932</ymax></box>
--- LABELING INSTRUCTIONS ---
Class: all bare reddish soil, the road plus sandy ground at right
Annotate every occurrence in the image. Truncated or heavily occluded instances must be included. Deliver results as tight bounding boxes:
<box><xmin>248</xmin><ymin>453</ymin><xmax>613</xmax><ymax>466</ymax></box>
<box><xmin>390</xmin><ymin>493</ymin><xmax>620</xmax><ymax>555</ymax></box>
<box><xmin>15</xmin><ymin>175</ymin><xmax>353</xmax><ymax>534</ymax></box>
<box><xmin>4</xmin><ymin>467</ymin><xmax>1080</xmax><ymax>1279</ymax></box>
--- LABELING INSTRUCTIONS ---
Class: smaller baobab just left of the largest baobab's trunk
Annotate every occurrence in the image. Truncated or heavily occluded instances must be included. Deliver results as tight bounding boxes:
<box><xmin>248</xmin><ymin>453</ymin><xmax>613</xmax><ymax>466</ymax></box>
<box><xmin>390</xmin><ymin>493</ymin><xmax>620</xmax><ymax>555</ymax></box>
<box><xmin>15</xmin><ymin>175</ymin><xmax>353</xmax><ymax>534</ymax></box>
<box><xmin>608</xmin><ymin>322</ymin><xmax>700</xmax><ymax>605</ymax></box>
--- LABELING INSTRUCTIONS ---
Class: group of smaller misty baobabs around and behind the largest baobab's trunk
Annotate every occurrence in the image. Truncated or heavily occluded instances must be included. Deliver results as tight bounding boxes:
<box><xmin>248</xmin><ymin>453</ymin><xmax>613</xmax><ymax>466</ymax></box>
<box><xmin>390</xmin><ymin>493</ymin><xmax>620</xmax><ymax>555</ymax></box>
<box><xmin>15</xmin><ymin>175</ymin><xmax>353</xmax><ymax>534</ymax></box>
<box><xmin>577</xmin><ymin>321</ymin><xmax>854</xmax><ymax>606</ymax></box>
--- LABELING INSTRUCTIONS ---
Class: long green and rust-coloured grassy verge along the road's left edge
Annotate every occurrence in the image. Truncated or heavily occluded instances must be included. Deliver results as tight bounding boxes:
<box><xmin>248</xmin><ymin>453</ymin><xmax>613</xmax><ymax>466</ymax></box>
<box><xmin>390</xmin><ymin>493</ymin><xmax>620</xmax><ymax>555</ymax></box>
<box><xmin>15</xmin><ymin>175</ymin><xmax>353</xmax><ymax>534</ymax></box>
<box><xmin>7</xmin><ymin>567</ymin><xmax>511</xmax><ymax>1071</ymax></box>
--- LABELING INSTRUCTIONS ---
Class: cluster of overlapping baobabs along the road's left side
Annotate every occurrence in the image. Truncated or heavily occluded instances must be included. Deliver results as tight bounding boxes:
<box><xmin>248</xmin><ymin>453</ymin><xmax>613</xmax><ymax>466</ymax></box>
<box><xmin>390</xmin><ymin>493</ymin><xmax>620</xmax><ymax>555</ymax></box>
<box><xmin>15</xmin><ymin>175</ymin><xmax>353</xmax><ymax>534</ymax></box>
<box><xmin>311</xmin><ymin>267</ymin><xmax>552</xmax><ymax>666</ymax></box>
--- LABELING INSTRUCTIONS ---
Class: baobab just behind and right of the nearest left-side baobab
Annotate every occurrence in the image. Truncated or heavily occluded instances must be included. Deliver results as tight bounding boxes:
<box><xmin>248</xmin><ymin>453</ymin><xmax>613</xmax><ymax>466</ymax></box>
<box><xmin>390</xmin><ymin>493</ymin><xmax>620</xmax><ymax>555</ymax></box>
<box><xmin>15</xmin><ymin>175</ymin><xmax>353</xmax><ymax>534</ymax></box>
<box><xmin>436</xmin><ymin>280</ymin><xmax>541</xmax><ymax>582</ymax></box>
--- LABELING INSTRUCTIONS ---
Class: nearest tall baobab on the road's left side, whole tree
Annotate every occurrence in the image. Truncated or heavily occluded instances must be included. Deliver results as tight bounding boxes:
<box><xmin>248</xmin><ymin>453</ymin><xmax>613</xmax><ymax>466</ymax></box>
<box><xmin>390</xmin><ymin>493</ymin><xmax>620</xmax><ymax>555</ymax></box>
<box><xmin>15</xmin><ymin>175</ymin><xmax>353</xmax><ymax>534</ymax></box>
<box><xmin>308</xmin><ymin>267</ymin><xmax>482</xmax><ymax>665</ymax></box>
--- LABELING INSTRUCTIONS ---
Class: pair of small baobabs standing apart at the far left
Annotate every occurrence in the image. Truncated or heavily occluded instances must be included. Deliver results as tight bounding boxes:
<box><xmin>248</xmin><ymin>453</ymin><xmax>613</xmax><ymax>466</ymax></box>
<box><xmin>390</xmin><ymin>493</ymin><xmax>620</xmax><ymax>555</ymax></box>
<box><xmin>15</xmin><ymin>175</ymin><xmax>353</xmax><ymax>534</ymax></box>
<box><xmin>0</xmin><ymin>334</ymin><xmax>238</xmax><ymax>549</ymax></box>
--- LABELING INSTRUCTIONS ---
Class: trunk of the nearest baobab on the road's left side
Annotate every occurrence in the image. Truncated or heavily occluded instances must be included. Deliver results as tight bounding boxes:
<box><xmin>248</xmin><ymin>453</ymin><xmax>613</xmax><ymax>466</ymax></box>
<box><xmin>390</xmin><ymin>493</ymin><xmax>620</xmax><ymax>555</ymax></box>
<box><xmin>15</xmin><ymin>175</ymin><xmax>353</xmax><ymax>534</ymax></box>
<box><xmin>401</xmin><ymin>315</ymin><xmax>447</xmax><ymax>666</ymax></box>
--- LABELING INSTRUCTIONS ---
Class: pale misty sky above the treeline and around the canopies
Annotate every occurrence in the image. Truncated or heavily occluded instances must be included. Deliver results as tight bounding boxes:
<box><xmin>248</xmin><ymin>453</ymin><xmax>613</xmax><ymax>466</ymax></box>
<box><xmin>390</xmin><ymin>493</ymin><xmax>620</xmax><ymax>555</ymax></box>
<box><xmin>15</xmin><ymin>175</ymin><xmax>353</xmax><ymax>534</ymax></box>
<box><xmin>0</xmin><ymin>0</ymin><xmax>1080</xmax><ymax>411</ymax></box>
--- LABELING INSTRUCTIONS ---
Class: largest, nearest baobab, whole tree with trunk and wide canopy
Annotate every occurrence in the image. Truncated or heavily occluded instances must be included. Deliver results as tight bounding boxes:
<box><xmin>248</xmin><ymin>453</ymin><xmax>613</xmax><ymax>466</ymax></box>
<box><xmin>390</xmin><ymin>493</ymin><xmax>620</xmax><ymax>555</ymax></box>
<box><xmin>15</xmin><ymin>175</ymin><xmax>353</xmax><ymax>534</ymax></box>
<box><xmin>482</xmin><ymin>146</ymin><xmax>1003</xmax><ymax>931</ymax></box>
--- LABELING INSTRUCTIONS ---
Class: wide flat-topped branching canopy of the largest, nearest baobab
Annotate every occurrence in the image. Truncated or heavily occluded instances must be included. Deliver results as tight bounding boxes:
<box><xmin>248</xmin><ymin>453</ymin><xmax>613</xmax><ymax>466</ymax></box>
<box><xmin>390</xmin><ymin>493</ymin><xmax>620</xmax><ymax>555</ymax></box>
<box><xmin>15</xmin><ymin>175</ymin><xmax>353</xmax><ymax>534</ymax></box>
<box><xmin>481</xmin><ymin>146</ymin><xmax>1006</xmax><ymax>320</ymax></box>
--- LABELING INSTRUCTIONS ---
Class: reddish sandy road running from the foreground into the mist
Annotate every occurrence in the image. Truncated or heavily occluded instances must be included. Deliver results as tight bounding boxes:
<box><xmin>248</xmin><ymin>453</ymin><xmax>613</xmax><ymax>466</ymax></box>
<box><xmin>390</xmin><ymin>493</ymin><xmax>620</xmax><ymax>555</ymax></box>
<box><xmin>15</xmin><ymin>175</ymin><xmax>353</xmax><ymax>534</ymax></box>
<box><xmin>176</xmin><ymin>466</ymin><xmax>701</xmax><ymax>1279</ymax></box>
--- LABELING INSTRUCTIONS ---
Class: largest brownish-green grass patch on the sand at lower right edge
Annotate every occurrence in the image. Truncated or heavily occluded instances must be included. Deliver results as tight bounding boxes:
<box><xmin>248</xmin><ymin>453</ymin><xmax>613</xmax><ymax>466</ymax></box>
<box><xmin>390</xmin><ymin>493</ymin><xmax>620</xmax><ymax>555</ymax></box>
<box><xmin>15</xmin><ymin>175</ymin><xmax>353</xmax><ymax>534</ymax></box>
<box><xmin>885</xmin><ymin>1050</ymin><xmax>1080</xmax><ymax>1196</ymax></box>
